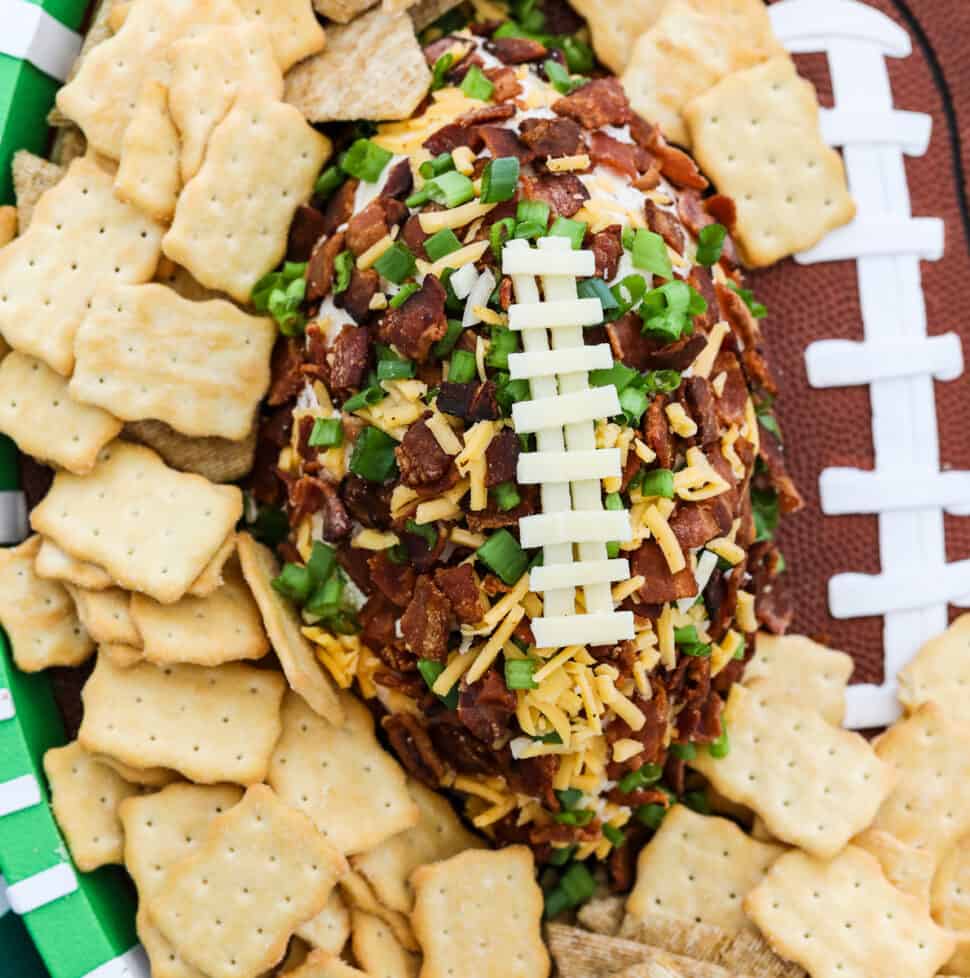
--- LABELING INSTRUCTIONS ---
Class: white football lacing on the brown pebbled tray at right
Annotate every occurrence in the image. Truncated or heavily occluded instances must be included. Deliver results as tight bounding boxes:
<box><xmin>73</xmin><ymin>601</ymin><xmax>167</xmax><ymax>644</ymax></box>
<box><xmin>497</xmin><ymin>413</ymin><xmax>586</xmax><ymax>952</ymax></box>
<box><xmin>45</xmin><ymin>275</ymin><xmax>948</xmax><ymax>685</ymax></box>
<box><xmin>769</xmin><ymin>0</ymin><xmax>956</xmax><ymax>728</ymax></box>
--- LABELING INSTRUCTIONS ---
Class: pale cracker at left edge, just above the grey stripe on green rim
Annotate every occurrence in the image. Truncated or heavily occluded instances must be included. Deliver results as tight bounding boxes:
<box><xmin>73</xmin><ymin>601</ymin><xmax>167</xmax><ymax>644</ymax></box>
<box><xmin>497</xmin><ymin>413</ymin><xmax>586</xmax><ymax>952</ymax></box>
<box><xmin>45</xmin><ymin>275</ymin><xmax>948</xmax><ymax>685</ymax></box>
<box><xmin>0</xmin><ymin>351</ymin><xmax>121</xmax><ymax>475</ymax></box>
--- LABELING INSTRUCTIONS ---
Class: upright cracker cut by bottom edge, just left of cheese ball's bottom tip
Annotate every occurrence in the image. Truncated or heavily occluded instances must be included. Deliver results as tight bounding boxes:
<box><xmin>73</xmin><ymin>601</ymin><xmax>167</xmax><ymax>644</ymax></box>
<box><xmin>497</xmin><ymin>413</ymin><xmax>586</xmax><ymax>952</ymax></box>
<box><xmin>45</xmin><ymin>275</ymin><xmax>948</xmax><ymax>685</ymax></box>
<box><xmin>411</xmin><ymin>846</ymin><xmax>549</xmax><ymax>978</ymax></box>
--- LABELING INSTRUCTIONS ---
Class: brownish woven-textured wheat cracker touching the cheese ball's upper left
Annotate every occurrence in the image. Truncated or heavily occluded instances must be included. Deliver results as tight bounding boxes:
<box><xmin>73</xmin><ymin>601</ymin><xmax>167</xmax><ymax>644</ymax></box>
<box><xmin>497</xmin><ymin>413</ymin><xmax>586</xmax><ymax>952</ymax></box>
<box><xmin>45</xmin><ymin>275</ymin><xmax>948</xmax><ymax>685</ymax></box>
<box><xmin>286</xmin><ymin>8</ymin><xmax>431</xmax><ymax>122</ymax></box>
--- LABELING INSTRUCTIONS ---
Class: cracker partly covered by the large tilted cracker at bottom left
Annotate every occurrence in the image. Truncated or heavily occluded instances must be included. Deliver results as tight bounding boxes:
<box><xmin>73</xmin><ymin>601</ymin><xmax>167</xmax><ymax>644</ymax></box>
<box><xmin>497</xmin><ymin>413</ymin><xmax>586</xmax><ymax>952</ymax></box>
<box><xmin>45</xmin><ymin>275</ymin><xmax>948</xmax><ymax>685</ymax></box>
<box><xmin>120</xmin><ymin>784</ymin><xmax>243</xmax><ymax>978</ymax></box>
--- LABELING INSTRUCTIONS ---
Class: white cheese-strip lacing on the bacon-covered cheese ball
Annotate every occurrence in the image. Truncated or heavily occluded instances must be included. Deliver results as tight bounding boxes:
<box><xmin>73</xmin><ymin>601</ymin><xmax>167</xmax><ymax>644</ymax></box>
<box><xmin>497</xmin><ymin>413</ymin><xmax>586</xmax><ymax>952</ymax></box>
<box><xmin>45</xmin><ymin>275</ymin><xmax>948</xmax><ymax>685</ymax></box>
<box><xmin>502</xmin><ymin>237</ymin><xmax>633</xmax><ymax>648</ymax></box>
